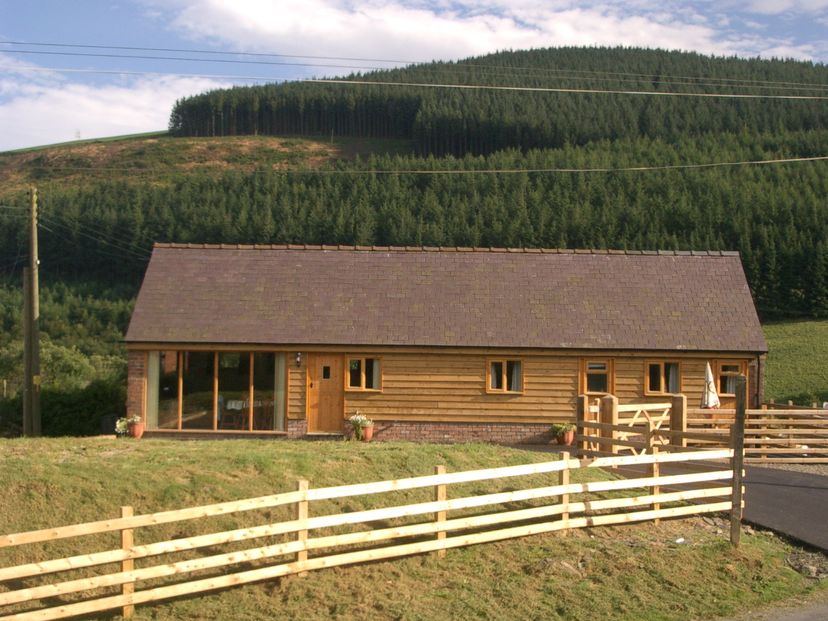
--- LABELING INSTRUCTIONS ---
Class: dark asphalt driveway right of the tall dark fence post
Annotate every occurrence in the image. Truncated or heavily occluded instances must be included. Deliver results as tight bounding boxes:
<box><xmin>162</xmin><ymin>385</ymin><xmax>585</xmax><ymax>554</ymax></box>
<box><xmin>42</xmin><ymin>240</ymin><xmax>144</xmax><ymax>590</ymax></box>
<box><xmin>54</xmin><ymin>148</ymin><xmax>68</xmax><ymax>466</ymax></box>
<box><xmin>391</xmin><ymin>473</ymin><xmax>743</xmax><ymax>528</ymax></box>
<box><xmin>744</xmin><ymin>466</ymin><xmax>828</xmax><ymax>552</ymax></box>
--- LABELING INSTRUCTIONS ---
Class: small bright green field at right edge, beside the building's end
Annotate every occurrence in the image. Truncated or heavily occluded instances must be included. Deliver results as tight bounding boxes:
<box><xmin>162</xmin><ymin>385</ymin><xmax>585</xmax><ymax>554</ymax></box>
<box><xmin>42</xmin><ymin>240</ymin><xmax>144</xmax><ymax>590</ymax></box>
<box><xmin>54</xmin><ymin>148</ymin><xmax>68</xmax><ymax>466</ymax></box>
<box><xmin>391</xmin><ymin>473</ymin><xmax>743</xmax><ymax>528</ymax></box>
<box><xmin>764</xmin><ymin>320</ymin><xmax>828</xmax><ymax>405</ymax></box>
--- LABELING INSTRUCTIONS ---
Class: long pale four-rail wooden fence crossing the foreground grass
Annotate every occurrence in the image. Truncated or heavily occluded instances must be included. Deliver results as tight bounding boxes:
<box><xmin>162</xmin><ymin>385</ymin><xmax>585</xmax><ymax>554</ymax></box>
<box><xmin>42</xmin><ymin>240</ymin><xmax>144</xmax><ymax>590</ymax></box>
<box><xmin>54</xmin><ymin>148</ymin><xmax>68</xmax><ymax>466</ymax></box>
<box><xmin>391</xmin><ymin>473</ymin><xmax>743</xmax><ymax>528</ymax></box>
<box><xmin>0</xmin><ymin>448</ymin><xmax>742</xmax><ymax>621</ymax></box>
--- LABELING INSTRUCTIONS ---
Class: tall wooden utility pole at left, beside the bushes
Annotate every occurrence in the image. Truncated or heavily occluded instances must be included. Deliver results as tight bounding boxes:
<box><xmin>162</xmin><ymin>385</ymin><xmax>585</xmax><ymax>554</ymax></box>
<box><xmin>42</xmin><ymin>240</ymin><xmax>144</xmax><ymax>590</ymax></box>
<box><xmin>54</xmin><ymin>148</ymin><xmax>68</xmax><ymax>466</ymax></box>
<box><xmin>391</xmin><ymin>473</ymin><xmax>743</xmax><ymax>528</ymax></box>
<box><xmin>23</xmin><ymin>186</ymin><xmax>41</xmax><ymax>436</ymax></box>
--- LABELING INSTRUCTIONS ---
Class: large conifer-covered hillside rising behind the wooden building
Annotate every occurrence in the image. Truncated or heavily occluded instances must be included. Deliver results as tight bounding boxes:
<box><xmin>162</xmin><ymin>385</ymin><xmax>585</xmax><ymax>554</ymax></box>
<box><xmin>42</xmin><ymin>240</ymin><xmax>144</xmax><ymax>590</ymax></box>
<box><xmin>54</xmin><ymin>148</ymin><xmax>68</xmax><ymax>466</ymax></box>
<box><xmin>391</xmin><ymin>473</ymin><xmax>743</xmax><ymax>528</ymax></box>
<box><xmin>0</xmin><ymin>48</ymin><xmax>828</xmax><ymax>428</ymax></box>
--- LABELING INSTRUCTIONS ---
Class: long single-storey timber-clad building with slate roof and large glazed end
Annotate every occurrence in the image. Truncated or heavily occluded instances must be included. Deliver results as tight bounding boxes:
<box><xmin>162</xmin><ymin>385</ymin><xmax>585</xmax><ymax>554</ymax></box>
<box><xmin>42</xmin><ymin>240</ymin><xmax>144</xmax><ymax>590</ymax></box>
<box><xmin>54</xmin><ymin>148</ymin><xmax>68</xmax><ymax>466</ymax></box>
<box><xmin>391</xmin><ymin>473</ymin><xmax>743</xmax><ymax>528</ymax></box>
<box><xmin>126</xmin><ymin>244</ymin><xmax>767</xmax><ymax>443</ymax></box>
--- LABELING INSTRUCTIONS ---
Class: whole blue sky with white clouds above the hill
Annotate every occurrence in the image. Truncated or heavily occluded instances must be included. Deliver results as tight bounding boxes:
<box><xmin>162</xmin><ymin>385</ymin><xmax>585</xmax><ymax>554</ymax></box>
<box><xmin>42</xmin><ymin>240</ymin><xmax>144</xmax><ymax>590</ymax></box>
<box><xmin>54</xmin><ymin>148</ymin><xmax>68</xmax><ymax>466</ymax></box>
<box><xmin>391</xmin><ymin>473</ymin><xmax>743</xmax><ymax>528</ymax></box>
<box><xmin>0</xmin><ymin>0</ymin><xmax>828</xmax><ymax>151</ymax></box>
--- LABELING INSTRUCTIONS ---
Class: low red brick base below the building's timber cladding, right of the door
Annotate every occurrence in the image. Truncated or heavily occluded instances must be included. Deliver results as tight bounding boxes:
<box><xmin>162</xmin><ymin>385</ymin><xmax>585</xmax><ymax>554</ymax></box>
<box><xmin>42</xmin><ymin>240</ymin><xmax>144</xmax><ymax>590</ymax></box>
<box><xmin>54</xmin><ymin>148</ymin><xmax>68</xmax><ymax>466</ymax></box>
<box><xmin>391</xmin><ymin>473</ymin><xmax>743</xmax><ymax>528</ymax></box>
<box><xmin>374</xmin><ymin>421</ymin><xmax>554</xmax><ymax>444</ymax></box>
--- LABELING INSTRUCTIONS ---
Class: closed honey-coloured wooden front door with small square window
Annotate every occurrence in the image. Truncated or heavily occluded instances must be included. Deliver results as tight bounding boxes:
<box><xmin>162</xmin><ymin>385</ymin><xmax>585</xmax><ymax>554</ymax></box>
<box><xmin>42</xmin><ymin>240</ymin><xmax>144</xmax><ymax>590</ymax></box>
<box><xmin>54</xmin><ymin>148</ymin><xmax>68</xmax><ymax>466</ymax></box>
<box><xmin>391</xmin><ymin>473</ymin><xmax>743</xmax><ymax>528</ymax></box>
<box><xmin>308</xmin><ymin>354</ymin><xmax>345</xmax><ymax>433</ymax></box>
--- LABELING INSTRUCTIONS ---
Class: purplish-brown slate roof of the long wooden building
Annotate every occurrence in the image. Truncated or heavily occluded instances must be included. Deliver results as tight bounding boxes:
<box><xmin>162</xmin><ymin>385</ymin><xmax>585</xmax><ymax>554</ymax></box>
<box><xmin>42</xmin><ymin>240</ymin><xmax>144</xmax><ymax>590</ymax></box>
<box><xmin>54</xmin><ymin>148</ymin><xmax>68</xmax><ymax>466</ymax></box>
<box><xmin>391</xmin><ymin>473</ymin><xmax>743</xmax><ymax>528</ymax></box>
<box><xmin>126</xmin><ymin>244</ymin><xmax>767</xmax><ymax>353</ymax></box>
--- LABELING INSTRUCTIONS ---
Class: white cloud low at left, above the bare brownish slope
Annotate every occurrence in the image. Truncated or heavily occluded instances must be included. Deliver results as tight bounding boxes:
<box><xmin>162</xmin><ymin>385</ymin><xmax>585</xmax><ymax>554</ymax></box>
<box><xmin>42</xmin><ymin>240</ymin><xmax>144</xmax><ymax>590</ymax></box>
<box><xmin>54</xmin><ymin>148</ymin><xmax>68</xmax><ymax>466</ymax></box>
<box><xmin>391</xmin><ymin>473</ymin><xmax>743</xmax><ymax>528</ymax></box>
<box><xmin>0</xmin><ymin>56</ymin><xmax>228</xmax><ymax>151</ymax></box>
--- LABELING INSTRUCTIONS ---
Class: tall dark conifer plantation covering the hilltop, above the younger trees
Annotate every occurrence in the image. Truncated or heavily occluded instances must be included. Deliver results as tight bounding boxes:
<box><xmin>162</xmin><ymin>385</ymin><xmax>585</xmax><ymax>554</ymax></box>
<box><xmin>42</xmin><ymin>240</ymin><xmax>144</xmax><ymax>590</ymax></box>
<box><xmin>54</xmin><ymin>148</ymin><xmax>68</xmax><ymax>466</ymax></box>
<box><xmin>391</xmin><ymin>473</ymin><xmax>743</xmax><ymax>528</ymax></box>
<box><xmin>170</xmin><ymin>47</ymin><xmax>828</xmax><ymax>156</ymax></box>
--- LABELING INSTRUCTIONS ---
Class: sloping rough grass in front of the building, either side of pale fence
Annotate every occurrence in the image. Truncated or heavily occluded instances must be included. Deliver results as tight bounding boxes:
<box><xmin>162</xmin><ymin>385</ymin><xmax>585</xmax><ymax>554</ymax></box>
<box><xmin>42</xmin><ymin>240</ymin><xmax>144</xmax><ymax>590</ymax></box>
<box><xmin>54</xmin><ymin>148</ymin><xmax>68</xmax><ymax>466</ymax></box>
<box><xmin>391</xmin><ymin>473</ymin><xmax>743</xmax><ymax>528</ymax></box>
<box><xmin>0</xmin><ymin>438</ymin><xmax>825</xmax><ymax>621</ymax></box>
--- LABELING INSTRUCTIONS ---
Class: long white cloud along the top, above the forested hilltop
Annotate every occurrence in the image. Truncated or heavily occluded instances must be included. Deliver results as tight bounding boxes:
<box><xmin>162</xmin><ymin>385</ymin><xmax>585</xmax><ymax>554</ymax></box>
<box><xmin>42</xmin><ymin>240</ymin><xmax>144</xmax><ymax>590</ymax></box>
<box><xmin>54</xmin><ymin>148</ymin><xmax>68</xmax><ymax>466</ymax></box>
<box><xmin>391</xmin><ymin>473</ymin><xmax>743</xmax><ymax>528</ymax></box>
<box><xmin>145</xmin><ymin>0</ymin><xmax>828</xmax><ymax>65</ymax></box>
